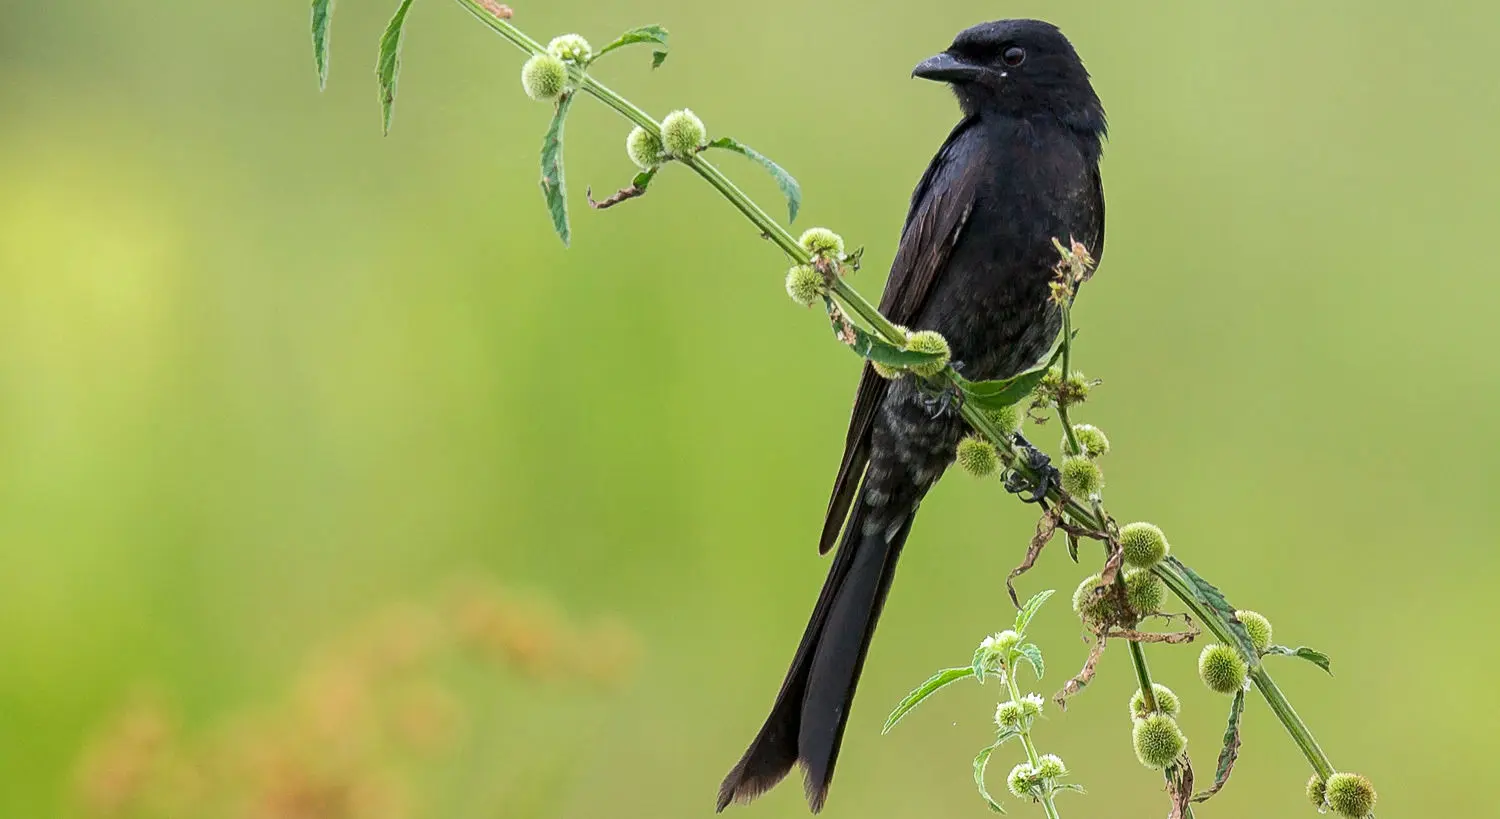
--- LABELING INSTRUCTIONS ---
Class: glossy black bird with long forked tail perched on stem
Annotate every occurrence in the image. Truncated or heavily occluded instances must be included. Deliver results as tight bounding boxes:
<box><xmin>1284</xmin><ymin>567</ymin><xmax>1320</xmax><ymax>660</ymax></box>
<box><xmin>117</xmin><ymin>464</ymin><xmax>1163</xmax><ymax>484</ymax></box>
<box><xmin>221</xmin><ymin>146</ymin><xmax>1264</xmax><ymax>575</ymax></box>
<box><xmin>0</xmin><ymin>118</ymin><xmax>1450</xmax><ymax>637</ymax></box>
<box><xmin>719</xmin><ymin>20</ymin><xmax>1106</xmax><ymax>812</ymax></box>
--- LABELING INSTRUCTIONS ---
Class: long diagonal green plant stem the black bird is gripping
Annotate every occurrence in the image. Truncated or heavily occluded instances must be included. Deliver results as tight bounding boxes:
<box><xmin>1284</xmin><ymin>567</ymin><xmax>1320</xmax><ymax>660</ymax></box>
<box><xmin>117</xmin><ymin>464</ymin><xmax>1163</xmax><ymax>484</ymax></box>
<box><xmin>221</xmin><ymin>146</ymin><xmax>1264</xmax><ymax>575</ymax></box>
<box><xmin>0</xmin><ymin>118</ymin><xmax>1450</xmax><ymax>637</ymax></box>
<box><xmin>455</xmin><ymin>0</ymin><xmax>1334</xmax><ymax>786</ymax></box>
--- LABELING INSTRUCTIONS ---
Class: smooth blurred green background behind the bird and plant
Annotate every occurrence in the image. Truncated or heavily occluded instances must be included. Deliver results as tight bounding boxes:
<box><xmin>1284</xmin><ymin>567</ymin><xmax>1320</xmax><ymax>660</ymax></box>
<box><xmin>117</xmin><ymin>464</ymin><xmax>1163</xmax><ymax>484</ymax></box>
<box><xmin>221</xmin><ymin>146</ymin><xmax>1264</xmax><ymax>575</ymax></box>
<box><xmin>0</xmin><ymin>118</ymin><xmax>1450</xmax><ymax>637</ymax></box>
<box><xmin>0</xmin><ymin>0</ymin><xmax>1500</xmax><ymax>819</ymax></box>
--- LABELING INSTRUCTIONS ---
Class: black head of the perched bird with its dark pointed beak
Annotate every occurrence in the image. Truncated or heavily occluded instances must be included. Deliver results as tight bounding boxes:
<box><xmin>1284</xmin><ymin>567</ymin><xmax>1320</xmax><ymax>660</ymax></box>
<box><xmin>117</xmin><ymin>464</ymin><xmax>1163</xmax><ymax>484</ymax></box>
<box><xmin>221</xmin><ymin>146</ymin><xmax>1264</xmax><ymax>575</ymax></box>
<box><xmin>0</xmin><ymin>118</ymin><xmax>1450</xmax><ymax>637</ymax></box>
<box><xmin>912</xmin><ymin>20</ymin><xmax>1106</xmax><ymax>137</ymax></box>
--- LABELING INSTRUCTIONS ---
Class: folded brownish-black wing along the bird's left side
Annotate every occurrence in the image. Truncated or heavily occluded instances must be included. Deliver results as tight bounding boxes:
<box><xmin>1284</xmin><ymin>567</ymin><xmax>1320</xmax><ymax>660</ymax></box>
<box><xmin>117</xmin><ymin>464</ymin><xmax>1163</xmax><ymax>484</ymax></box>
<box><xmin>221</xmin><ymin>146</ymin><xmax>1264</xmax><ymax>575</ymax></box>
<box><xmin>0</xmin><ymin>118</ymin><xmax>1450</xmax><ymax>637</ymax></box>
<box><xmin>818</xmin><ymin>117</ymin><xmax>986</xmax><ymax>552</ymax></box>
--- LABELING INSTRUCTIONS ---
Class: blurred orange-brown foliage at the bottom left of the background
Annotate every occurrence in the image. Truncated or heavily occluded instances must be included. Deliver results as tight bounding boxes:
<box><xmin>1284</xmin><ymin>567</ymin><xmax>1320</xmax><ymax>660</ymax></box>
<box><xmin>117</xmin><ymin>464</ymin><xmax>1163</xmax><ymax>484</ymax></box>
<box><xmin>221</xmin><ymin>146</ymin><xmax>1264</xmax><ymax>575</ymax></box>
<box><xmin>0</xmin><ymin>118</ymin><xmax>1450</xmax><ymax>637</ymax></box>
<box><xmin>77</xmin><ymin>573</ymin><xmax>635</xmax><ymax>819</ymax></box>
